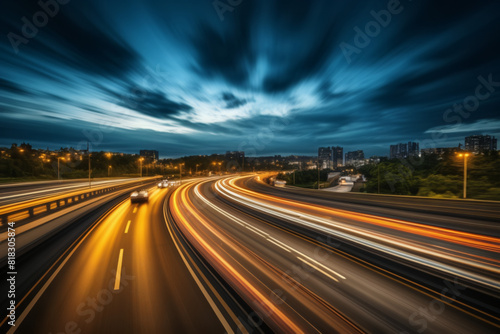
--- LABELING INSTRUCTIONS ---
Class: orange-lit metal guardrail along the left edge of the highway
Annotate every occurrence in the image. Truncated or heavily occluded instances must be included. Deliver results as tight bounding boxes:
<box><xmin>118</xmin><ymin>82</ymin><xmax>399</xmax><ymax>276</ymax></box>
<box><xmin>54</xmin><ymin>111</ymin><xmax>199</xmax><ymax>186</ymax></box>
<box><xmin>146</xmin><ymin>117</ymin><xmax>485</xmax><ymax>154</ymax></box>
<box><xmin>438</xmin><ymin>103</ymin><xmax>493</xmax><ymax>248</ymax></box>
<box><xmin>0</xmin><ymin>180</ymin><xmax>158</xmax><ymax>227</ymax></box>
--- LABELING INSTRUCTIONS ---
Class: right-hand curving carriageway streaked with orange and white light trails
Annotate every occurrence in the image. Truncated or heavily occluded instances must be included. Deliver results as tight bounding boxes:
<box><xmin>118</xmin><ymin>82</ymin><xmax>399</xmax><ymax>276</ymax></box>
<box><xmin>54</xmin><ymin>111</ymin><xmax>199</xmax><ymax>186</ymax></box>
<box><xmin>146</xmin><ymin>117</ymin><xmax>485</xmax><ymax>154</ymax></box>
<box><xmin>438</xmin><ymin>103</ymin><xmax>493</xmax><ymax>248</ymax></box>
<box><xmin>170</xmin><ymin>177</ymin><xmax>500</xmax><ymax>333</ymax></box>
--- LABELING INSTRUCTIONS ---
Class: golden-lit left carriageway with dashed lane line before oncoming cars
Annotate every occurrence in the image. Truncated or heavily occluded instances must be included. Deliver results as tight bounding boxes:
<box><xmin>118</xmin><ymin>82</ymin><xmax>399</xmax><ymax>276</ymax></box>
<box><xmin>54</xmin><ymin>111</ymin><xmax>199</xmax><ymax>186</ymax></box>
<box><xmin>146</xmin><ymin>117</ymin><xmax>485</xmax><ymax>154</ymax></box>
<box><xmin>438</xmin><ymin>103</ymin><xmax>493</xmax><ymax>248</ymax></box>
<box><xmin>4</xmin><ymin>184</ymin><xmax>234</xmax><ymax>333</ymax></box>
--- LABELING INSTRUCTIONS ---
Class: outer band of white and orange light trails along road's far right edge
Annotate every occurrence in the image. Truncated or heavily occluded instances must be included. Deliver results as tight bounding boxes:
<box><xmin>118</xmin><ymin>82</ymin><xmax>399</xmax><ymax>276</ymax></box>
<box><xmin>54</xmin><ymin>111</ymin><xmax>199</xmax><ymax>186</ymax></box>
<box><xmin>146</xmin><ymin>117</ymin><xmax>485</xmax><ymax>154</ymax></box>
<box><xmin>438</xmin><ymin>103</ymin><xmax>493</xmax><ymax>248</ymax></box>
<box><xmin>214</xmin><ymin>177</ymin><xmax>500</xmax><ymax>289</ymax></box>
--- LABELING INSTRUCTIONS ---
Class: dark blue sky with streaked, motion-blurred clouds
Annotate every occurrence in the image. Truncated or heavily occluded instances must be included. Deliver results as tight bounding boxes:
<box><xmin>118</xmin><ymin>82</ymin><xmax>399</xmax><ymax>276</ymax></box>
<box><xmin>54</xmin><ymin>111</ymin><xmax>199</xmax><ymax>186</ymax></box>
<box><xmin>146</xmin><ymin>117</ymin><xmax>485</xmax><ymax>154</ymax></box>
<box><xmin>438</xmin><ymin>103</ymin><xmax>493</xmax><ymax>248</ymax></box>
<box><xmin>0</xmin><ymin>0</ymin><xmax>500</xmax><ymax>157</ymax></box>
